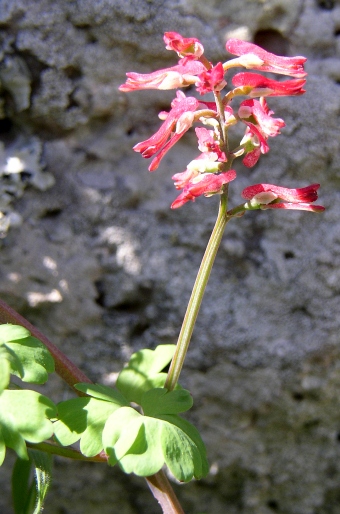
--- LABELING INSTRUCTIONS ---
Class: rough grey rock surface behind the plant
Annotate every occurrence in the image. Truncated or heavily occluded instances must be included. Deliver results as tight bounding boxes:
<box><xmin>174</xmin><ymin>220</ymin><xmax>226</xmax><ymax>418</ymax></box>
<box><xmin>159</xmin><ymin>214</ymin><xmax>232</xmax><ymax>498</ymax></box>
<box><xmin>0</xmin><ymin>0</ymin><xmax>340</xmax><ymax>514</ymax></box>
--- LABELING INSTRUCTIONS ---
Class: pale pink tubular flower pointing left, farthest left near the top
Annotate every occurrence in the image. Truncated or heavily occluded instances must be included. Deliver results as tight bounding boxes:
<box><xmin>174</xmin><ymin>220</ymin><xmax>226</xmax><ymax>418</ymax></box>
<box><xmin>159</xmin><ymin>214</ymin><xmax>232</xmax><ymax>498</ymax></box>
<box><xmin>119</xmin><ymin>60</ymin><xmax>206</xmax><ymax>93</ymax></box>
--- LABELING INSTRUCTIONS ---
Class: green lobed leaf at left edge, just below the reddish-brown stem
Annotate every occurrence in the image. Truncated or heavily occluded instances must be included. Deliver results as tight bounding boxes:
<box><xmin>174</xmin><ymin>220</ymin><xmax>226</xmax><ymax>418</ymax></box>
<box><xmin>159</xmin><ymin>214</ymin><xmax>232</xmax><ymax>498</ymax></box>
<box><xmin>0</xmin><ymin>324</ymin><xmax>54</xmax><ymax>382</ymax></box>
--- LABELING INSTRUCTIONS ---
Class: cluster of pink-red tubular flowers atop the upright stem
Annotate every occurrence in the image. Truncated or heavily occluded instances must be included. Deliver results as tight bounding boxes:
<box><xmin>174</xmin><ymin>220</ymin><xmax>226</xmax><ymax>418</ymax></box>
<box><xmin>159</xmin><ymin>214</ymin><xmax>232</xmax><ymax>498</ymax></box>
<box><xmin>119</xmin><ymin>32</ymin><xmax>324</xmax><ymax>215</ymax></box>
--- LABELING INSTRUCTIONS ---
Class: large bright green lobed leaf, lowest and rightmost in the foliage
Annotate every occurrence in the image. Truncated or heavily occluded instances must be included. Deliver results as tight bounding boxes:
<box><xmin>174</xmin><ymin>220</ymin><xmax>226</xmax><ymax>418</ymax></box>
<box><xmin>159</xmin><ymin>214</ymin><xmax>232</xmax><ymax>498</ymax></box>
<box><xmin>103</xmin><ymin>403</ymin><xmax>209</xmax><ymax>482</ymax></box>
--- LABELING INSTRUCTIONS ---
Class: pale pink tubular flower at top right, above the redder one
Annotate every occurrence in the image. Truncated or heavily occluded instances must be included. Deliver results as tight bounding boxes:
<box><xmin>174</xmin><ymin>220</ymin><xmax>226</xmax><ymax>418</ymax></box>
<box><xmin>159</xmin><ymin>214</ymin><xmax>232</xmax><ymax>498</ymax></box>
<box><xmin>226</xmin><ymin>39</ymin><xmax>307</xmax><ymax>78</ymax></box>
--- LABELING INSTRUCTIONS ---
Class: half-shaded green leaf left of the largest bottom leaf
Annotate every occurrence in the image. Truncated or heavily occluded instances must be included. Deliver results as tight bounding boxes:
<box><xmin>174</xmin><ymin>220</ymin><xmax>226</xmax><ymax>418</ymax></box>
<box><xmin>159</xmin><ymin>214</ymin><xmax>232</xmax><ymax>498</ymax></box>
<box><xmin>54</xmin><ymin>392</ymin><xmax>126</xmax><ymax>457</ymax></box>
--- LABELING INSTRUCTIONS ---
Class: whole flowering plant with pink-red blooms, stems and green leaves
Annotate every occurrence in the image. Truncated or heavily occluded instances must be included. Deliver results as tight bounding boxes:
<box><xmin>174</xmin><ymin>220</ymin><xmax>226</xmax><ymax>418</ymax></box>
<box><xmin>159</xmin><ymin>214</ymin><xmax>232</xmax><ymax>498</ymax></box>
<box><xmin>0</xmin><ymin>32</ymin><xmax>324</xmax><ymax>514</ymax></box>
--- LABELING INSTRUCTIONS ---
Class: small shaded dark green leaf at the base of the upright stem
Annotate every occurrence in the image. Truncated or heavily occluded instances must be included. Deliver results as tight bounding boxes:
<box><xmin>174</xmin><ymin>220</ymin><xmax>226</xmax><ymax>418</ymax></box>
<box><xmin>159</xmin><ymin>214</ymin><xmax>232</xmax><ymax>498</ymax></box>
<box><xmin>141</xmin><ymin>388</ymin><xmax>193</xmax><ymax>417</ymax></box>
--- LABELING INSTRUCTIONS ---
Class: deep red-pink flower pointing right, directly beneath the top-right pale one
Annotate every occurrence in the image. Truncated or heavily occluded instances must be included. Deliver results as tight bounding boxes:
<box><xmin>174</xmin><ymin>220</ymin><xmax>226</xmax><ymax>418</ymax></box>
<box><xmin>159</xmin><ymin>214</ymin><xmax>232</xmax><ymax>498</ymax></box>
<box><xmin>232</xmin><ymin>72</ymin><xmax>306</xmax><ymax>98</ymax></box>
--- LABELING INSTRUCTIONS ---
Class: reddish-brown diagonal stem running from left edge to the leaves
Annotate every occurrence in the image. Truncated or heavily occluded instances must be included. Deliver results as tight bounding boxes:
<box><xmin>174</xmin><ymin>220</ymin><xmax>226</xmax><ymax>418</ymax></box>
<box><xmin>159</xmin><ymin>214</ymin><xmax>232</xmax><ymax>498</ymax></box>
<box><xmin>0</xmin><ymin>299</ymin><xmax>92</xmax><ymax>388</ymax></box>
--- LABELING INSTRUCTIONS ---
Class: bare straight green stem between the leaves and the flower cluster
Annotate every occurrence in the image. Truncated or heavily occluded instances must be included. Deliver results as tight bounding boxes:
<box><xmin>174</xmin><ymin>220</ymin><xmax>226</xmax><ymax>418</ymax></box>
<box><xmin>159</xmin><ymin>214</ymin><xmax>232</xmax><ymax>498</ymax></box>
<box><xmin>164</xmin><ymin>193</ymin><xmax>230</xmax><ymax>391</ymax></box>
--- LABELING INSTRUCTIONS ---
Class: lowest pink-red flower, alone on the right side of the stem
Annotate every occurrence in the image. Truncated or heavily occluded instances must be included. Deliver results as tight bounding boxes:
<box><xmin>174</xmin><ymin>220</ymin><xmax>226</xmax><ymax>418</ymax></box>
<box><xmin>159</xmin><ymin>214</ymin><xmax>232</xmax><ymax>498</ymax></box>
<box><xmin>242</xmin><ymin>184</ymin><xmax>325</xmax><ymax>212</ymax></box>
